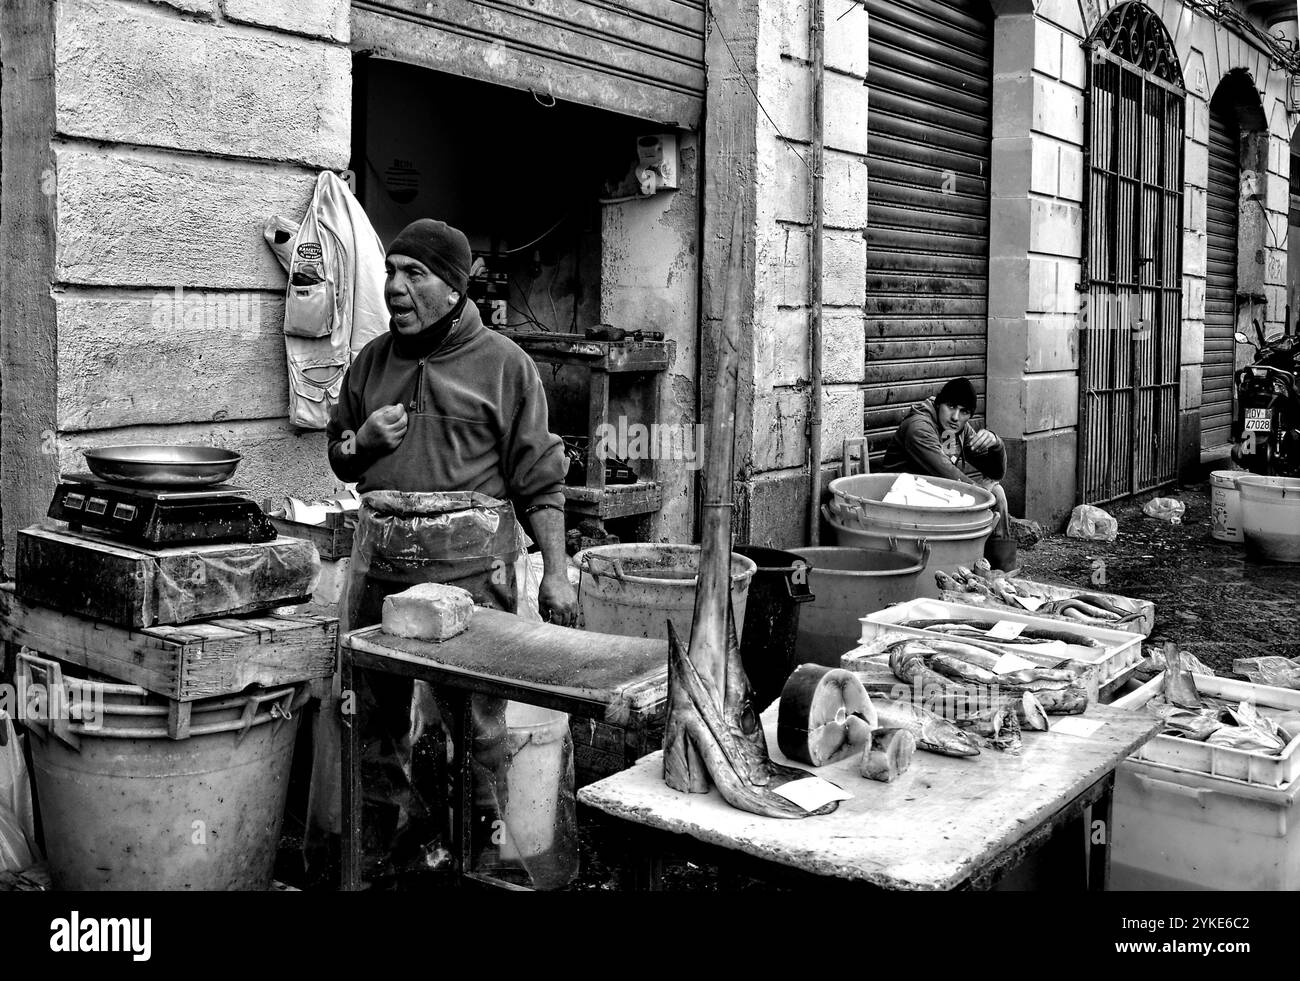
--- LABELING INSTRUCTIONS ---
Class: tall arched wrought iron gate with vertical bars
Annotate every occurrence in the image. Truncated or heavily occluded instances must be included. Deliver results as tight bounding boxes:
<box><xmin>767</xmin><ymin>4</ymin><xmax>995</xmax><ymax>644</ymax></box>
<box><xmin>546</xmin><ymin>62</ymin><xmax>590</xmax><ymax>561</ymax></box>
<box><xmin>1079</xmin><ymin>3</ymin><xmax>1186</xmax><ymax>503</ymax></box>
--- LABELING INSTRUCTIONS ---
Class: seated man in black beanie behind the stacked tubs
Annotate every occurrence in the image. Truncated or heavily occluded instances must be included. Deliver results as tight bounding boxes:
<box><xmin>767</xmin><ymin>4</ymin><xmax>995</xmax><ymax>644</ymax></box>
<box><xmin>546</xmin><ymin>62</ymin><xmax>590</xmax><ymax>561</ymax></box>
<box><xmin>880</xmin><ymin>378</ymin><xmax>1010</xmax><ymax>539</ymax></box>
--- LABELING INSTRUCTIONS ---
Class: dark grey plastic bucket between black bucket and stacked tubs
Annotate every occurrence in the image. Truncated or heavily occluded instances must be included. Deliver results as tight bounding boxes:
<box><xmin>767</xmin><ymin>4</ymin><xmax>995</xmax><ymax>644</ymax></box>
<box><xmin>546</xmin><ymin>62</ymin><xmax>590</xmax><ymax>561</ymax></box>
<box><xmin>794</xmin><ymin>547</ymin><xmax>926</xmax><ymax>668</ymax></box>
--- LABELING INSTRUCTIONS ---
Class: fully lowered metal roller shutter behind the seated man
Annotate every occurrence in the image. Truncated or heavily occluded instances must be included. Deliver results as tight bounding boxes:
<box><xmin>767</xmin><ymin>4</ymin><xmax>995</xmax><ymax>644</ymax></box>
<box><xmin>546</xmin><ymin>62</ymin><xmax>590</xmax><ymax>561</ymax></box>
<box><xmin>865</xmin><ymin>0</ymin><xmax>993</xmax><ymax>452</ymax></box>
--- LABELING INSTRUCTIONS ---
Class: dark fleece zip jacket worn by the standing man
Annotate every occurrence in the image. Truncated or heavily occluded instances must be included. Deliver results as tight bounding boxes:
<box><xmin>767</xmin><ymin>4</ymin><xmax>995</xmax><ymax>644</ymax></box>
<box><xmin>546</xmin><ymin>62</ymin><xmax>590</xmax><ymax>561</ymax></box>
<box><xmin>326</xmin><ymin>303</ymin><xmax>568</xmax><ymax>515</ymax></box>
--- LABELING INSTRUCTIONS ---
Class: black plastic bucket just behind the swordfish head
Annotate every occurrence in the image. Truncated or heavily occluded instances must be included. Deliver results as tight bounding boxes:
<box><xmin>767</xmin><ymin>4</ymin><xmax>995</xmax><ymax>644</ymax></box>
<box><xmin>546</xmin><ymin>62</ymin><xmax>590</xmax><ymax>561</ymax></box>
<box><xmin>736</xmin><ymin>544</ymin><xmax>814</xmax><ymax>707</ymax></box>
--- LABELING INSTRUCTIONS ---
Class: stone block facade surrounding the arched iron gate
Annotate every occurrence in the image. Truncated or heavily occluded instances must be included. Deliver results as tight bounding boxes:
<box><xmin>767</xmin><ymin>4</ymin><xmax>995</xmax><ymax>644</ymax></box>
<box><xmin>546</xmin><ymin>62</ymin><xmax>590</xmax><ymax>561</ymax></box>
<box><xmin>988</xmin><ymin>0</ymin><xmax>1294</xmax><ymax>526</ymax></box>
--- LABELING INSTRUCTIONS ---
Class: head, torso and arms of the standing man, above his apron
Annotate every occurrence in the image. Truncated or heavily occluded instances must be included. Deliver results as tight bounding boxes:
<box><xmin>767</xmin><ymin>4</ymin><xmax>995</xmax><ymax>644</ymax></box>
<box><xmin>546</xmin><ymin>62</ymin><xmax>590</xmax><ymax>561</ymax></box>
<box><xmin>326</xmin><ymin>218</ymin><xmax>577</xmax><ymax>629</ymax></box>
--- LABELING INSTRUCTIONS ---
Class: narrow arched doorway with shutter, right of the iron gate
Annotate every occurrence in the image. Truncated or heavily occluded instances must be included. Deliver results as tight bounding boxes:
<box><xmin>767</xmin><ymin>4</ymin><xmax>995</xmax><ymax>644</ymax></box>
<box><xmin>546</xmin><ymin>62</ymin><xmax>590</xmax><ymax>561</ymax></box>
<box><xmin>1200</xmin><ymin>71</ymin><xmax>1268</xmax><ymax>456</ymax></box>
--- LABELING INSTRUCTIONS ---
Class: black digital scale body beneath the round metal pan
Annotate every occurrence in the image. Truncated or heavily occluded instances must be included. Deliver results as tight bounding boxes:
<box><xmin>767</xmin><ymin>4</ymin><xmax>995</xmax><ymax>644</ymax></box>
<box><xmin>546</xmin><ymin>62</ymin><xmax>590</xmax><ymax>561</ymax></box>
<box><xmin>48</xmin><ymin>473</ymin><xmax>276</xmax><ymax>548</ymax></box>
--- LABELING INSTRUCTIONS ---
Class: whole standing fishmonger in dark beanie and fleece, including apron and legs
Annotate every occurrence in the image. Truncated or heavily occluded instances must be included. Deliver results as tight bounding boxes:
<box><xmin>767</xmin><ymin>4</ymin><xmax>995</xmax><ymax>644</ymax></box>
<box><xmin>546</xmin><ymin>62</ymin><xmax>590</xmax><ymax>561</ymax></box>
<box><xmin>313</xmin><ymin>218</ymin><xmax>577</xmax><ymax>883</ymax></box>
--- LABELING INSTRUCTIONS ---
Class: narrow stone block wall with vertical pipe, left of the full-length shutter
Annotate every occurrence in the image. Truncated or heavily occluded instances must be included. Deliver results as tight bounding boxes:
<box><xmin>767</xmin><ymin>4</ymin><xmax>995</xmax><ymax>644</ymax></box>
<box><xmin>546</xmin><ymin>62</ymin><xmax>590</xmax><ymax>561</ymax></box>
<box><xmin>728</xmin><ymin>0</ymin><xmax>868</xmax><ymax>547</ymax></box>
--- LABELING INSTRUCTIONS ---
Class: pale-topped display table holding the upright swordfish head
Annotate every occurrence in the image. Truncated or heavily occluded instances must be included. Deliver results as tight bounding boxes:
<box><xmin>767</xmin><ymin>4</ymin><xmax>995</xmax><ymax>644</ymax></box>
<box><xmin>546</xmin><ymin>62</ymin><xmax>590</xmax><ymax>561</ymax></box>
<box><xmin>579</xmin><ymin>704</ymin><xmax>1160</xmax><ymax>890</ymax></box>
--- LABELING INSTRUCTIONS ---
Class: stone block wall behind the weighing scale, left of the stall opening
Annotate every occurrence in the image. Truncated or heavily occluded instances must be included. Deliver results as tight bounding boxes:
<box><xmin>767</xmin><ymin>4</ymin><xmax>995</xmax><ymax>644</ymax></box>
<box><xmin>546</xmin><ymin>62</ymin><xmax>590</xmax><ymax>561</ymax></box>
<box><xmin>0</xmin><ymin>0</ymin><xmax>352</xmax><ymax>561</ymax></box>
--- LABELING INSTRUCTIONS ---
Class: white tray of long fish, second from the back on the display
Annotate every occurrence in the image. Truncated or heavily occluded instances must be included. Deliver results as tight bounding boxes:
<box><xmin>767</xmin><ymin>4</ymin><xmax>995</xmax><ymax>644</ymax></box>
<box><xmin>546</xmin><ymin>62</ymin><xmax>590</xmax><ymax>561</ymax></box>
<box><xmin>858</xmin><ymin>599</ymin><xmax>1141</xmax><ymax>685</ymax></box>
